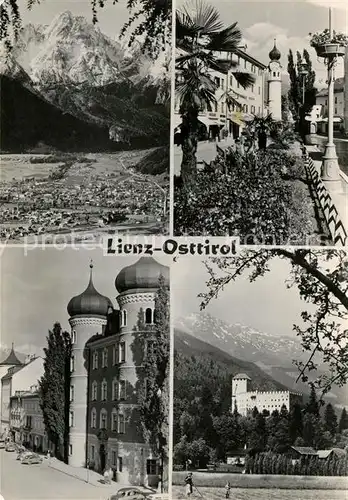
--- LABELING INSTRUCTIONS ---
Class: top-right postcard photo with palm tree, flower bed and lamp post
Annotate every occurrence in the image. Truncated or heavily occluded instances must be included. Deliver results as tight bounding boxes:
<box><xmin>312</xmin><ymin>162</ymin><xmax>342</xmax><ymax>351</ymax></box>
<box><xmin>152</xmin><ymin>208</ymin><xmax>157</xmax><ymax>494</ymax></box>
<box><xmin>171</xmin><ymin>0</ymin><xmax>348</xmax><ymax>246</ymax></box>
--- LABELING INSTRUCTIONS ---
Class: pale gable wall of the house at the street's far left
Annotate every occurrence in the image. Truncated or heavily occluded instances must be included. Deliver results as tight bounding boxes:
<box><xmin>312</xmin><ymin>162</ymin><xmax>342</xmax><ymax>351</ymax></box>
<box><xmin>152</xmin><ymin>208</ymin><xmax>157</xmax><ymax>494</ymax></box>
<box><xmin>1</xmin><ymin>357</ymin><xmax>43</xmax><ymax>431</ymax></box>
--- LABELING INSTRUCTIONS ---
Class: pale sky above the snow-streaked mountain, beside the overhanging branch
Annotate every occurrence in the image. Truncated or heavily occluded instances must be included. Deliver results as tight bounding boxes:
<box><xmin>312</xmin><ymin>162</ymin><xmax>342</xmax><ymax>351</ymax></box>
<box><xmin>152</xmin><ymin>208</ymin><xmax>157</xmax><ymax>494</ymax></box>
<box><xmin>171</xmin><ymin>257</ymin><xmax>316</xmax><ymax>336</ymax></box>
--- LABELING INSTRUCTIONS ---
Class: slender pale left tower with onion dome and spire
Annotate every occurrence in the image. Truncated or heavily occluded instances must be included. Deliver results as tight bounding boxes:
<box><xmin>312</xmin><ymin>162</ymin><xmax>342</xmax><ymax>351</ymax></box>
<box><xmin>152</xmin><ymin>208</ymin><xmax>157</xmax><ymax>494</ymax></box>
<box><xmin>67</xmin><ymin>263</ymin><xmax>113</xmax><ymax>467</ymax></box>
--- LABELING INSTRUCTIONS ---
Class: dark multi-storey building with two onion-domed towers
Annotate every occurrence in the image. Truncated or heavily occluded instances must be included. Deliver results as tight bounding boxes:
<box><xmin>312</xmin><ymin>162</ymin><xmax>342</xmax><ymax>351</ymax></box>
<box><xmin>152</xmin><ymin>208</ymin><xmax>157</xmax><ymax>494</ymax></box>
<box><xmin>68</xmin><ymin>257</ymin><xmax>169</xmax><ymax>486</ymax></box>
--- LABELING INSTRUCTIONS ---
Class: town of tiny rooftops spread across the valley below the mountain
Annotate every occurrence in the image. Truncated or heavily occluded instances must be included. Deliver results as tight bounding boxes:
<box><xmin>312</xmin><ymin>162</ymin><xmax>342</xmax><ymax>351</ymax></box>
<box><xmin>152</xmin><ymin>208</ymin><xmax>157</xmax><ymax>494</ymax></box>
<box><xmin>0</xmin><ymin>164</ymin><xmax>164</xmax><ymax>239</ymax></box>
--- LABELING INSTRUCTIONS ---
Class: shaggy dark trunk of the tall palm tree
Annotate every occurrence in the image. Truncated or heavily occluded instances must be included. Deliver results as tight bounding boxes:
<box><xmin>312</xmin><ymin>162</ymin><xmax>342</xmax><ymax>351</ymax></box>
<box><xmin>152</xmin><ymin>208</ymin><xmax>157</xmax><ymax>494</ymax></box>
<box><xmin>181</xmin><ymin>109</ymin><xmax>199</xmax><ymax>187</ymax></box>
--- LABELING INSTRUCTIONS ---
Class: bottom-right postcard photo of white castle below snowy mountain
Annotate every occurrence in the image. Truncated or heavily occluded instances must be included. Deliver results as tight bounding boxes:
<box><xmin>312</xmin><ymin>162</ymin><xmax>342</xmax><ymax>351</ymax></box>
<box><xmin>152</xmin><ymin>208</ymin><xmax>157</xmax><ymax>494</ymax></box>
<box><xmin>171</xmin><ymin>252</ymin><xmax>348</xmax><ymax>500</ymax></box>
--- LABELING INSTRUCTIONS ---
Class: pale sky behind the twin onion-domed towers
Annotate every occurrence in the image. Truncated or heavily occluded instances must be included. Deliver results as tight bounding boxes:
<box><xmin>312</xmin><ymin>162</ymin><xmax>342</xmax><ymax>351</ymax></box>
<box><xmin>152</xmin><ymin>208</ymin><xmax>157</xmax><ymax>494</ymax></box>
<box><xmin>0</xmin><ymin>247</ymin><xmax>168</xmax><ymax>354</ymax></box>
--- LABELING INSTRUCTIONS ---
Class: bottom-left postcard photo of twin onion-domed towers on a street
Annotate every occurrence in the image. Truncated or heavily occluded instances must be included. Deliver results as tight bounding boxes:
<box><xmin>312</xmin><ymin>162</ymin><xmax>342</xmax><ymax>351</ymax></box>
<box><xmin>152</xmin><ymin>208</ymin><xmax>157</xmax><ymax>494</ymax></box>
<box><xmin>0</xmin><ymin>247</ymin><xmax>170</xmax><ymax>500</ymax></box>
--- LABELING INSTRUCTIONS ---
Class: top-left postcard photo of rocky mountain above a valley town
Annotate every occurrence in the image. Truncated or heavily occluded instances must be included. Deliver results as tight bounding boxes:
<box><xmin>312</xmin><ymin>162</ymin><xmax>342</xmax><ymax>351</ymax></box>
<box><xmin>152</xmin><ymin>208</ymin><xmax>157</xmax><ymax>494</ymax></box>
<box><xmin>0</xmin><ymin>0</ymin><xmax>171</xmax><ymax>243</ymax></box>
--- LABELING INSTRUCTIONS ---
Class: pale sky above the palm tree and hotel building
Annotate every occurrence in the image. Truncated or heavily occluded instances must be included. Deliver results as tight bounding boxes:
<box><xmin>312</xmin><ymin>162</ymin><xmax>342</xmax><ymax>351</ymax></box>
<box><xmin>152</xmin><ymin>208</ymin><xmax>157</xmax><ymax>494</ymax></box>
<box><xmin>177</xmin><ymin>0</ymin><xmax>348</xmax><ymax>83</ymax></box>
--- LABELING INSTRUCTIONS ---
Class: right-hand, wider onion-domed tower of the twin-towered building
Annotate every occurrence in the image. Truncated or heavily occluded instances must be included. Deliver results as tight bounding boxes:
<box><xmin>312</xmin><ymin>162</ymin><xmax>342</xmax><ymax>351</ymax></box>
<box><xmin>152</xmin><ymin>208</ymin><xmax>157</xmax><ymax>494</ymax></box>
<box><xmin>115</xmin><ymin>257</ymin><xmax>169</xmax><ymax>485</ymax></box>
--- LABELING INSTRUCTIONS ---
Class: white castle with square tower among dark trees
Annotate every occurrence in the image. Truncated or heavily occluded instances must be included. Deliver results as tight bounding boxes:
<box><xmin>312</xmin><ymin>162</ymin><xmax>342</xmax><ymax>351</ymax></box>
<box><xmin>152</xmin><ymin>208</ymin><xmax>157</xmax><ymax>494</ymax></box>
<box><xmin>232</xmin><ymin>373</ymin><xmax>302</xmax><ymax>416</ymax></box>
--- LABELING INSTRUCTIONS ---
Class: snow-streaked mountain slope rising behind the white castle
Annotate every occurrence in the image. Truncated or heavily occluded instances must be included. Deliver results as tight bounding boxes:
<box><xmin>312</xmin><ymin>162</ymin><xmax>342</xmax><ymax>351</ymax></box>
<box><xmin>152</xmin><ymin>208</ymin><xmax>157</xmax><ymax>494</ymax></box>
<box><xmin>174</xmin><ymin>313</ymin><xmax>348</xmax><ymax>406</ymax></box>
